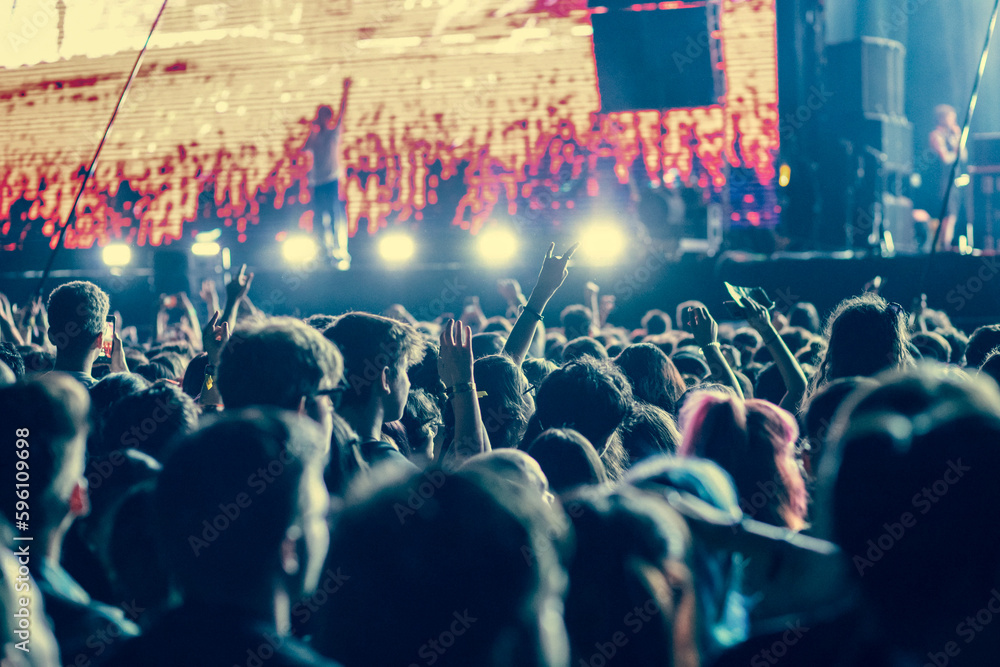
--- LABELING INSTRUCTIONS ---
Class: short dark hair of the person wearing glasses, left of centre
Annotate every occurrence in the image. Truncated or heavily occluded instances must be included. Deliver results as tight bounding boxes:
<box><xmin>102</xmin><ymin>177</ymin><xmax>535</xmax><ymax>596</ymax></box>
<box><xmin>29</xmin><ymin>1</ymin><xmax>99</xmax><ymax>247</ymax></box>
<box><xmin>218</xmin><ymin>317</ymin><xmax>343</xmax><ymax>410</ymax></box>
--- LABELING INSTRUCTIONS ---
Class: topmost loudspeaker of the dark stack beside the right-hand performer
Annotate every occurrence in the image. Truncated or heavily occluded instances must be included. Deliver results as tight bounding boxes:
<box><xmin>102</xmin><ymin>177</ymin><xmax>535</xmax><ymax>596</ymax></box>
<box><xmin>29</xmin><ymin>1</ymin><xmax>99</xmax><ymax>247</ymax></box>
<box><xmin>826</xmin><ymin>37</ymin><xmax>906</xmax><ymax>116</ymax></box>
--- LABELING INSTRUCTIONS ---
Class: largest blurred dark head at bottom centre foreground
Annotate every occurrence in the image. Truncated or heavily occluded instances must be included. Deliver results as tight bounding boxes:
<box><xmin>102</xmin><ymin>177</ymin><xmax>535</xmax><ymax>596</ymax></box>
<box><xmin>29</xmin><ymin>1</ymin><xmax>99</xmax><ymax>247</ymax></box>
<box><xmin>311</xmin><ymin>469</ymin><xmax>568</xmax><ymax>667</ymax></box>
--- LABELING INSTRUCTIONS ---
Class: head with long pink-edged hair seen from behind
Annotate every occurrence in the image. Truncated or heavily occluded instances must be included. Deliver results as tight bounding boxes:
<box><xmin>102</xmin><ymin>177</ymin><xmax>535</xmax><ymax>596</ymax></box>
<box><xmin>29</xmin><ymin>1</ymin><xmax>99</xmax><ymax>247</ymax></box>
<box><xmin>680</xmin><ymin>391</ymin><xmax>807</xmax><ymax>530</ymax></box>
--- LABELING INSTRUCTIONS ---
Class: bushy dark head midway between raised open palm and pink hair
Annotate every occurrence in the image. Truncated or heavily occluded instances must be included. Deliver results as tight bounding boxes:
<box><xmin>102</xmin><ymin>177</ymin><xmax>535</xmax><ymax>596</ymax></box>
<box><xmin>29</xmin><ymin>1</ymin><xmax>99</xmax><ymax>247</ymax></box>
<box><xmin>524</xmin><ymin>357</ymin><xmax>633</xmax><ymax>462</ymax></box>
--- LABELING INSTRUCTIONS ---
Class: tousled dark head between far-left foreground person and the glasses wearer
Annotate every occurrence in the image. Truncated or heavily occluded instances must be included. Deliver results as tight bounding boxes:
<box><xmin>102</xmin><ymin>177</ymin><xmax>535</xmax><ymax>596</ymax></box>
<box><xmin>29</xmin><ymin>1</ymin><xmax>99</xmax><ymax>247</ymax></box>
<box><xmin>100</xmin><ymin>382</ymin><xmax>198</xmax><ymax>461</ymax></box>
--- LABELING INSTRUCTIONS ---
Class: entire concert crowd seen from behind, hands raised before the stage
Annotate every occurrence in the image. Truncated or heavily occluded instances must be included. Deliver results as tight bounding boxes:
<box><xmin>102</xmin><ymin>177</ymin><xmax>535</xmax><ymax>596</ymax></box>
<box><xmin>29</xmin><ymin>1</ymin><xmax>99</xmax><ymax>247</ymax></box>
<box><xmin>0</xmin><ymin>244</ymin><xmax>1000</xmax><ymax>667</ymax></box>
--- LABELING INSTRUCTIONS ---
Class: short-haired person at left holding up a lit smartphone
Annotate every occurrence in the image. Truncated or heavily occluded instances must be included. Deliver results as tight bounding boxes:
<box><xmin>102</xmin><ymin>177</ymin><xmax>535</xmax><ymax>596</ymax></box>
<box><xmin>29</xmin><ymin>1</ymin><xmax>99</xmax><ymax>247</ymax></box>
<box><xmin>48</xmin><ymin>280</ymin><xmax>128</xmax><ymax>389</ymax></box>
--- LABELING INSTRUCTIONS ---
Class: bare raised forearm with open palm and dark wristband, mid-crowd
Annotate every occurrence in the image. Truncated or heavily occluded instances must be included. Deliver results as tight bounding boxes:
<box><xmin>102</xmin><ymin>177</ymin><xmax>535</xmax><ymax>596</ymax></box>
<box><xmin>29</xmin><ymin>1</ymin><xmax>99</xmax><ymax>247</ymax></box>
<box><xmin>438</xmin><ymin>320</ymin><xmax>490</xmax><ymax>469</ymax></box>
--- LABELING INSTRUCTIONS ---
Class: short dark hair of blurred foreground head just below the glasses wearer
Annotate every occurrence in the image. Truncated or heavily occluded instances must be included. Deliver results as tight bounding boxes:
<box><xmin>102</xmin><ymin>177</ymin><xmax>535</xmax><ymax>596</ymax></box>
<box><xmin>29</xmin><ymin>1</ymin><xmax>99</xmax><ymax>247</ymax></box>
<box><xmin>153</xmin><ymin>410</ymin><xmax>326</xmax><ymax>595</ymax></box>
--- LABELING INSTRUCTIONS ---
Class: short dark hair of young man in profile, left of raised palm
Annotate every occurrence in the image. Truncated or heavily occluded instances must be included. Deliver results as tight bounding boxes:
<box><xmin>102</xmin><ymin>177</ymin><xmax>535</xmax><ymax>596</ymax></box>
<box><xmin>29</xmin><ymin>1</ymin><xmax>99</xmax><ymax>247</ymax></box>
<box><xmin>323</xmin><ymin>312</ymin><xmax>424</xmax><ymax>405</ymax></box>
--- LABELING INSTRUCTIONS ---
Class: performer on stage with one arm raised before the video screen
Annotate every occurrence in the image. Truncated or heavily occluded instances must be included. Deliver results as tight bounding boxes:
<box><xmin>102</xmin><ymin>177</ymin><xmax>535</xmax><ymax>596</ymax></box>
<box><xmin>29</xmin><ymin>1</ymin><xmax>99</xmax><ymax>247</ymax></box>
<box><xmin>303</xmin><ymin>78</ymin><xmax>351</xmax><ymax>271</ymax></box>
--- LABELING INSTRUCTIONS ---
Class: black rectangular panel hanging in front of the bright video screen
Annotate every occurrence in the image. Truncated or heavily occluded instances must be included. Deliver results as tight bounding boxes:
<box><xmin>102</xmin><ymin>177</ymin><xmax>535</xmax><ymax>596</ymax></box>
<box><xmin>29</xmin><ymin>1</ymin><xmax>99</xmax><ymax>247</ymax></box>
<box><xmin>591</xmin><ymin>7</ymin><xmax>718</xmax><ymax>113</ymax></box>
